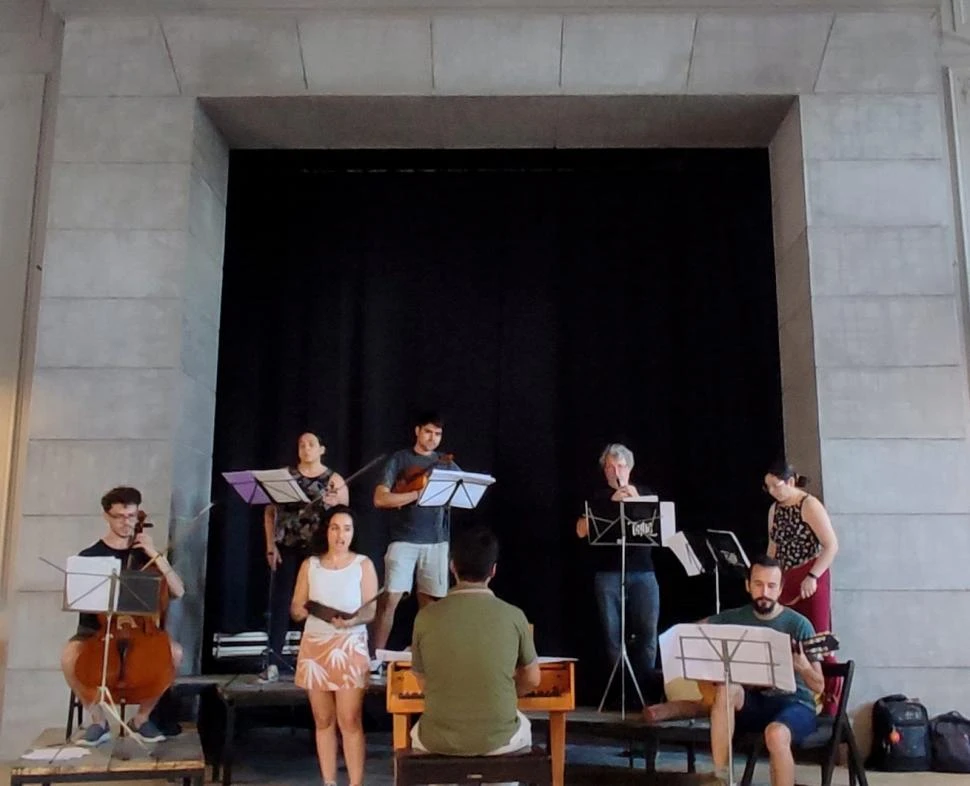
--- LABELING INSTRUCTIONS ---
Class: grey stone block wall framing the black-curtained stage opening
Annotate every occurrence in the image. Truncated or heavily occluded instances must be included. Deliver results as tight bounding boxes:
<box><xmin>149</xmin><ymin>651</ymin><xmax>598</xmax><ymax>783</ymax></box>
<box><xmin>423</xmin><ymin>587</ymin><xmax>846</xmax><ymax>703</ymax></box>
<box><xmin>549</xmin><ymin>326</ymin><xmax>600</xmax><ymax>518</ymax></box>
<box><xmin>4</xmin><ymin>0</ymin><xmax>970</xmax><ymax>752</ymax></box>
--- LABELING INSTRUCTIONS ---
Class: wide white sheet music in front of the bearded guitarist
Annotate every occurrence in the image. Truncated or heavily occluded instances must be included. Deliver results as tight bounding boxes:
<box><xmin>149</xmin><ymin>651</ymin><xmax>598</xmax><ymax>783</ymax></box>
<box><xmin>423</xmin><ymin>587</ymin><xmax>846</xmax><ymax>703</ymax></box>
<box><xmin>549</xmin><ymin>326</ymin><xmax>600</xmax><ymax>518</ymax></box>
<box><xmin>658</xmin><ymin>623</ymin><xmax>795</xmax><ymax>693</ymax></box>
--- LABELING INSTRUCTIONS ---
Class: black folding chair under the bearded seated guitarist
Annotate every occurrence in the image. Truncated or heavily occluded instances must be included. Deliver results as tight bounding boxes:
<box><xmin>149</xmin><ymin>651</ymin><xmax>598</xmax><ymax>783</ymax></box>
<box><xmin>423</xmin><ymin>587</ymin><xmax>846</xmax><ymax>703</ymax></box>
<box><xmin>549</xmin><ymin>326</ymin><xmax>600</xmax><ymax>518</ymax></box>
<box><xmin>741</xmin><ymin>660</ymin><xmax>869</xmax><ymax>786</ymax></box>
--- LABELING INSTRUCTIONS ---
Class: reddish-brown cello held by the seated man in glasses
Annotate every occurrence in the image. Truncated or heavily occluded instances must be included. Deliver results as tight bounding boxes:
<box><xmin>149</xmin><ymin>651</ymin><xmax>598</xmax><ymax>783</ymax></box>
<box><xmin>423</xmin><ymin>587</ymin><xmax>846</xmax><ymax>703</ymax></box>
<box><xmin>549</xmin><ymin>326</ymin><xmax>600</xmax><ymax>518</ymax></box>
<box><xmin>75</xmin><ymin>510</ymin><xmax>175</xmax><ymax>704</ymax></box>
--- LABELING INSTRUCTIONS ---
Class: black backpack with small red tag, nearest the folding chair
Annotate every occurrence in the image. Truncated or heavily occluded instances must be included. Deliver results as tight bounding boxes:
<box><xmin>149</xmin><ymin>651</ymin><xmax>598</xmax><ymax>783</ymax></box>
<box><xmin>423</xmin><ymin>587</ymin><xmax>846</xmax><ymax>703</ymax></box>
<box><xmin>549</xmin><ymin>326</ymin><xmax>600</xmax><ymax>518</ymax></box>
<box><xmin>866</xmin><ymin>693</ymin><xmax>932</xmax><ymax>772</ymax></box>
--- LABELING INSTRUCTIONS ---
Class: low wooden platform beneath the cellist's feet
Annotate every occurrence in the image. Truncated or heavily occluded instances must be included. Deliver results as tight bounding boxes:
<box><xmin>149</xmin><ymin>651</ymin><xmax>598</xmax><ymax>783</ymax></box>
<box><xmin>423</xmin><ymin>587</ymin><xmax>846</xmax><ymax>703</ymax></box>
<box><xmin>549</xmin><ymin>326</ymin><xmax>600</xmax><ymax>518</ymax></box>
<box><xmin>10</xmin><ymin>728</ymin><xmax>205</xmax><ymax>786</ymax></box>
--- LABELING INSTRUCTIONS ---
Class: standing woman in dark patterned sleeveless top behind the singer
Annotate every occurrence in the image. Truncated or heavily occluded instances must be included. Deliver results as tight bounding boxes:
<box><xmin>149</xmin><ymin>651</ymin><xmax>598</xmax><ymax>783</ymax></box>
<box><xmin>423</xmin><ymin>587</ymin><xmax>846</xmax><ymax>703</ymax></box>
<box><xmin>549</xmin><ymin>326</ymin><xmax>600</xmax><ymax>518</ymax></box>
<box><xmin>261</xmin><ymin>431</ymin><xmax>350</xmax><ymax>682</ymax></box>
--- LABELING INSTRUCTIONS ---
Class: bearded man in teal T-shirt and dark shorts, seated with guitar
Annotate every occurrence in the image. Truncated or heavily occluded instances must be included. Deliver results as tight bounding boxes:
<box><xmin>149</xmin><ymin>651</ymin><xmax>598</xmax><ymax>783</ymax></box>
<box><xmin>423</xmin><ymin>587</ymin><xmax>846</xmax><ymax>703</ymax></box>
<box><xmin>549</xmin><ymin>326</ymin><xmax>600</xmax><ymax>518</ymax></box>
<box><xmin>644</xmin><ymin>557</ymin><xmax>824</xmax><ymax>786</ymax></box>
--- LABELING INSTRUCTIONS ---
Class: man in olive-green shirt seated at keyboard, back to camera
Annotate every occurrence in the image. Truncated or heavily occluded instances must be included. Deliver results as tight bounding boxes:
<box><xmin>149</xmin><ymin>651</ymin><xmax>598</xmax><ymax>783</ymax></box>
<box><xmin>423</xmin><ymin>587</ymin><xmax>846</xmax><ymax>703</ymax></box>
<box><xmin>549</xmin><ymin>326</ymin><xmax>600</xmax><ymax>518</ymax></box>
<box><xmin>411</xmin><ymin>527</ymin><xmax>541</xmax><ymax>756</ymax></box>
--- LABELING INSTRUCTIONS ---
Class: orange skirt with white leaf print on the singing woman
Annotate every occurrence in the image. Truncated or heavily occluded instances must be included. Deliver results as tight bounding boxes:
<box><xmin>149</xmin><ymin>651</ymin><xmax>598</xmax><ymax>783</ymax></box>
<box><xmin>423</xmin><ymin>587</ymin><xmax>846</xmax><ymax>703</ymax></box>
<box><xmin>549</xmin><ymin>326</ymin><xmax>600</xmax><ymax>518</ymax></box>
<box><xmin>294</xmin><ymin>630</ymin><xmax>370</xmax><ymax>691</ymax></box>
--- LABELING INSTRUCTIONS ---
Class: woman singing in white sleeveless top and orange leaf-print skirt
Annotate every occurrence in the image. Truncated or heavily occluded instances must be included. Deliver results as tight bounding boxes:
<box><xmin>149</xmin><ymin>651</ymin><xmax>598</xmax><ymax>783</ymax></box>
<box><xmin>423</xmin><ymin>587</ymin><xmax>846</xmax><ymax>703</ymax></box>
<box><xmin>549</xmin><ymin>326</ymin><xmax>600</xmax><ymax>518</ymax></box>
<box><xmin>290</xmin><ymin>505</ymin><xmax>377</xmax><ymax>786</ymax></box>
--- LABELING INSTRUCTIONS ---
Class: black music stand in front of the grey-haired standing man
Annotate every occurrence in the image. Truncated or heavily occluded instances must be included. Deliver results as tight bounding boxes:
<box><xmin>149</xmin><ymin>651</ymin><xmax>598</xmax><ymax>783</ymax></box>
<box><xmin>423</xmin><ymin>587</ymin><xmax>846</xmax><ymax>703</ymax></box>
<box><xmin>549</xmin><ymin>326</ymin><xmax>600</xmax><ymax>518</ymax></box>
<box><xmin>586</xmin><ymin>495</ymin><xmax>662</xmax><ymax>720</ymax></box>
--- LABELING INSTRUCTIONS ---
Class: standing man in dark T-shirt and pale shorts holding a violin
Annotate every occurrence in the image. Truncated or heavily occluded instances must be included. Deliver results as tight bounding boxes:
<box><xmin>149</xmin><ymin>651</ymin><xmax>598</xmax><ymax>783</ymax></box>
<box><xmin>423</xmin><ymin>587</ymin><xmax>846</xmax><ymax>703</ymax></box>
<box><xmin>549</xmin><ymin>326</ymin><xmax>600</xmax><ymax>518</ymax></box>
<box><xmin>373</xmin><ymin>412</ymin><xmax>458</xmax><ymax>660</ymax></box>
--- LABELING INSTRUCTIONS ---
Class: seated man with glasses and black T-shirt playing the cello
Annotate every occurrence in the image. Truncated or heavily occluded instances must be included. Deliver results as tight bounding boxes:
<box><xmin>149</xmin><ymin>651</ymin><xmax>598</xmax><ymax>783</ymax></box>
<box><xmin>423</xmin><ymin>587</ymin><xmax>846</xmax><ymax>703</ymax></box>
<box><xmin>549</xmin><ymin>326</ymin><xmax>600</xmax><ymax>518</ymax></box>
<box><xmin>61</xmin><ymin>486</ymin><xmax>185</xmax><ymax>746</ymax></box>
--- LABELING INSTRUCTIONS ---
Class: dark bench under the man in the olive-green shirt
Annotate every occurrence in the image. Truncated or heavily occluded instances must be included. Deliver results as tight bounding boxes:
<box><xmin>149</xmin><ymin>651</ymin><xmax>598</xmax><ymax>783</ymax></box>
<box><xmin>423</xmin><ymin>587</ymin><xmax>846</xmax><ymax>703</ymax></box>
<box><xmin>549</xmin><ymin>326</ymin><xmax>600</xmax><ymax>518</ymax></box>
<box><xmin>394</xmin><ymin>748</ymin><xmax>552</xmax><ymax>786</ymax></box>
